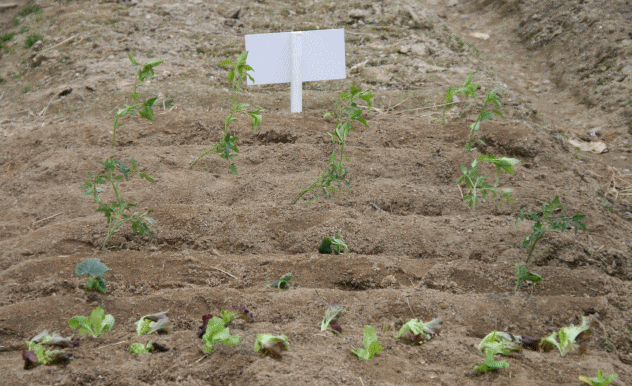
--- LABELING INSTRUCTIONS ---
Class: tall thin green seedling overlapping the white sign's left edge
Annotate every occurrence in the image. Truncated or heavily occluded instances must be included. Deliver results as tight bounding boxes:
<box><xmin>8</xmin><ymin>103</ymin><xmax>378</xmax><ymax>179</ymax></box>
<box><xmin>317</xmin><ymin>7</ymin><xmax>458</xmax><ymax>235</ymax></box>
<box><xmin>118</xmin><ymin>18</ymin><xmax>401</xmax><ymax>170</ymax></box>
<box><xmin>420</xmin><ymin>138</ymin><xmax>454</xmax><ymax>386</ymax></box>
<box><xmin>189</xmin><ymin>51</ymin><xmax>262</xmax><ymax>175</ymax></box>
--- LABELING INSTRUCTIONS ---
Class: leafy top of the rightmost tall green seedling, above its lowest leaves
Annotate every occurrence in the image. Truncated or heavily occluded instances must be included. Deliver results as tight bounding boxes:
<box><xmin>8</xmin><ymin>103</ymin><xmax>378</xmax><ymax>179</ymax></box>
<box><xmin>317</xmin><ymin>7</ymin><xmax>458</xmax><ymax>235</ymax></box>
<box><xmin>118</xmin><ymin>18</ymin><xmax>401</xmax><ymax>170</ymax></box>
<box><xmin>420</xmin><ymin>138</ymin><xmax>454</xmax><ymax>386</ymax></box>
<box><xmin>516</xmin><ymin>196</ymin><xmax>586</xmax><ymax>262</ymax></box>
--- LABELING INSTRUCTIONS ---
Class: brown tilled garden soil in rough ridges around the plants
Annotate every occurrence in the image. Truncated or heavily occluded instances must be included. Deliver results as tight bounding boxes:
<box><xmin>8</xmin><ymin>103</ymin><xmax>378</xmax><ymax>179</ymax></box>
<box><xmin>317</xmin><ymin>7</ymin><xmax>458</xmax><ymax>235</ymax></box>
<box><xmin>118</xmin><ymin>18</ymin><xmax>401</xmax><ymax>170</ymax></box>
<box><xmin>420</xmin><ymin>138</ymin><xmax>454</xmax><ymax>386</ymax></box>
<box><xmin>0</xmin><ymin>0</ymin><xmax>632</xmax><ymax>386</ymax></box>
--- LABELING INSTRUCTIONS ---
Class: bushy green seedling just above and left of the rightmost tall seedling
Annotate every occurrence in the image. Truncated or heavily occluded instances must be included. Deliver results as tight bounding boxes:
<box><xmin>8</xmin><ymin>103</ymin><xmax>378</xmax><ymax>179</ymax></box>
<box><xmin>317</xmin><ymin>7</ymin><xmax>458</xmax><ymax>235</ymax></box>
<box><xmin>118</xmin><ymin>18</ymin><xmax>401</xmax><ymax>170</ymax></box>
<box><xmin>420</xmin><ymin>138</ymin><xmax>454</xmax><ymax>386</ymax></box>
<box><xmin>456</xmin><ymin>154</ymin><xmax>520</xmax><ymax>213</ymax></box>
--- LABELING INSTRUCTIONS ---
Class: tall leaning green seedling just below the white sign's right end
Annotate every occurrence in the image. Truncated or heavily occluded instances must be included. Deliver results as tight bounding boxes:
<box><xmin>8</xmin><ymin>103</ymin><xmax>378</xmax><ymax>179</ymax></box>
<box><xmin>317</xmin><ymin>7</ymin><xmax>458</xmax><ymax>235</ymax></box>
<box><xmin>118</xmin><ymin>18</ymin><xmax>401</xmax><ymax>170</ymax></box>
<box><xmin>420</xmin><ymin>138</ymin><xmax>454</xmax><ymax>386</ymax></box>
<box><xmin>292</xmin><ymin>84</ymin><xmax>373</xmax><ymax>204</ymax></box>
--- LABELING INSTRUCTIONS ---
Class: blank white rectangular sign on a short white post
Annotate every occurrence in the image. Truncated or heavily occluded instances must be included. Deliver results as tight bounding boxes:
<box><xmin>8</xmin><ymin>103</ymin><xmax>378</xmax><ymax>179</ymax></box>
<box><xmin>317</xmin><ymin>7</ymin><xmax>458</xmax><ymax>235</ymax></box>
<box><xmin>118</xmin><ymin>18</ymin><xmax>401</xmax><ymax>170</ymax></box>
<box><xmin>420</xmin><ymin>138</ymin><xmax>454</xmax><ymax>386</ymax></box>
<box><xmin>246</xmin><ymin>29</ymin><xmax>346</xmax><ymax>113</ymax></box>
